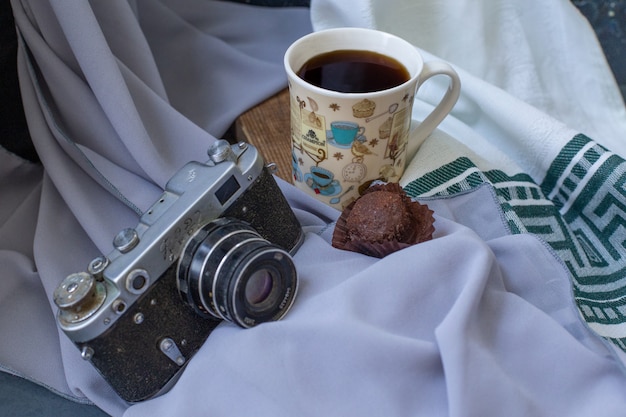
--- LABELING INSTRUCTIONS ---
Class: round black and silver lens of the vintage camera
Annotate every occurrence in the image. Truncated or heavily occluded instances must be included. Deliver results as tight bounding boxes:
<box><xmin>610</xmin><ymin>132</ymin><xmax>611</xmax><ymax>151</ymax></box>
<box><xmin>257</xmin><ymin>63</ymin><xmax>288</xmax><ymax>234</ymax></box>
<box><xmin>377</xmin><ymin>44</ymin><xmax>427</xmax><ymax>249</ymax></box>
<box><xmin>177</xmin><ymin>218</ymin><xmax>298</xmax><ymax>327</ymax></box>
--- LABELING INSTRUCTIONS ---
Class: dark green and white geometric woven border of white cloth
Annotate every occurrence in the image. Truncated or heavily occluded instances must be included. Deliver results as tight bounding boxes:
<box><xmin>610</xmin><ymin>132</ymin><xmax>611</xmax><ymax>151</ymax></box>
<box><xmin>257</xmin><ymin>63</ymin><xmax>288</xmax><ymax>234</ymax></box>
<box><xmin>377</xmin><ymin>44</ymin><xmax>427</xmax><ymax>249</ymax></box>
<box><xmin>405</xmin><ymin>134</ymin><xmax>626</xmax><ymax>351</ymax></box>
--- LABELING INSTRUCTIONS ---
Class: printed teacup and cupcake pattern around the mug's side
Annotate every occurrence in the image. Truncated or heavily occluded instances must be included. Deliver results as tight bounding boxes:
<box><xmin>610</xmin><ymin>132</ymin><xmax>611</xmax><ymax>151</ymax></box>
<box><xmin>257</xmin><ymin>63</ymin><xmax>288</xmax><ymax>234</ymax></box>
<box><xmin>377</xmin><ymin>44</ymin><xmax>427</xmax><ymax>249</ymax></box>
<box><xmin>291</xmin><ymin>92</ymin><xmax>413</xmax><ymax>207</ymax></box>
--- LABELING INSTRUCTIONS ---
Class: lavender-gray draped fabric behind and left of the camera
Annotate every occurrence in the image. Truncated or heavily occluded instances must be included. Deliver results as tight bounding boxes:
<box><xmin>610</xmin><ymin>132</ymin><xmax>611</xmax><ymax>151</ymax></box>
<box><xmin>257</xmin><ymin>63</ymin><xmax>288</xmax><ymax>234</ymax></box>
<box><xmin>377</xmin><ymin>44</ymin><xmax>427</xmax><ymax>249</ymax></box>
<box><xmin>0</xmin><ymin>0</ymin><xmax>311</xmax><ymax>414</ymax></box>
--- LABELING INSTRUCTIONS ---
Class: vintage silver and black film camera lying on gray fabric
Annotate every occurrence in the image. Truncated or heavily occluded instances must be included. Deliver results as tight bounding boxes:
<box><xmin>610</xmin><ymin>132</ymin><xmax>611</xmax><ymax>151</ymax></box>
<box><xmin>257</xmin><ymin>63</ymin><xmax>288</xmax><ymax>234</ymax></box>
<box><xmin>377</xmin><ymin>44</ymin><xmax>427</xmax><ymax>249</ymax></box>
<box><xmin>54</xmin><ymin>140</ymin><xmax>303</xmax><ymax>402</ymax></box>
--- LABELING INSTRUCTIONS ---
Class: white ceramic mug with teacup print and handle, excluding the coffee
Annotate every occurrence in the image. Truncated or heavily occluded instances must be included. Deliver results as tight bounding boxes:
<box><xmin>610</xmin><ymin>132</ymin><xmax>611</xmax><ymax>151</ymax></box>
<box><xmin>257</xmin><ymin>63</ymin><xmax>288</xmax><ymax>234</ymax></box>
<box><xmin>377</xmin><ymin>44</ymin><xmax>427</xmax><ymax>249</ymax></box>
<box><xmin>284</xmin><ymin>28</ymin><xmax>461</xmax><ymax>210</ymax></box>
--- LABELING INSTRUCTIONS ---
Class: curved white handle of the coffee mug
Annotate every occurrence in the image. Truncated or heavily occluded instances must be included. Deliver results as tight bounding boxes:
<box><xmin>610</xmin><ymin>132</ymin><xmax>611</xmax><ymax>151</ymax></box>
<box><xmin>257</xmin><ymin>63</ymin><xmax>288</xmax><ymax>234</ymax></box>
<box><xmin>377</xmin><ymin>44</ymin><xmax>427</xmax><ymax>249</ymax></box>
<box><xmin>411</xmin><ymin>61</ymin><xmax>461</xmax><ymax>144</ymax></box>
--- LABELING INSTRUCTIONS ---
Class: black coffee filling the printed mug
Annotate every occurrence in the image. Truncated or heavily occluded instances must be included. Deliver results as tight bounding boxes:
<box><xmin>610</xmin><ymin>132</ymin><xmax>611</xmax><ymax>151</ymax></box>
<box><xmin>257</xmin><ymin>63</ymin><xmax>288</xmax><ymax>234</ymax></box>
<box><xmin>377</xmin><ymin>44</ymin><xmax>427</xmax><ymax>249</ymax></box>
<box><xmin>297</xmin><ymin>50</ymin><xmax>411</xmax><ymax>93</ymax></box>
